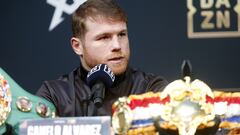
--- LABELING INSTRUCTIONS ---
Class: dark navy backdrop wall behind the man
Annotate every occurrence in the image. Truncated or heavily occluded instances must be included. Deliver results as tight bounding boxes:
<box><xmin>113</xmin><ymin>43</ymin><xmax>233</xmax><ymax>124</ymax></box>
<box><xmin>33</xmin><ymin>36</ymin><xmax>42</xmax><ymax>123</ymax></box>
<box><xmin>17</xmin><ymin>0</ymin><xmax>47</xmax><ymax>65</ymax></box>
<box><xmin>0</xmin><ymin>0</ymin><xmax>240</xmax><ymax>93</ymax></box>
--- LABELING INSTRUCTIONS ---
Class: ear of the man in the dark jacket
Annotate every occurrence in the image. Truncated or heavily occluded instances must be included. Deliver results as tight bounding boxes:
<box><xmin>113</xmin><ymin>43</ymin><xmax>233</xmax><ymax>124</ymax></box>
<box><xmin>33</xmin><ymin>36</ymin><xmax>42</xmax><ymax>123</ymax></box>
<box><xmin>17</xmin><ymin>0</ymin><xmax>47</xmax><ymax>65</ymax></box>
<box><xmin>71</xmin><ymin>37</ymin><xmax>83</xmax><ymax>56</ymax></box>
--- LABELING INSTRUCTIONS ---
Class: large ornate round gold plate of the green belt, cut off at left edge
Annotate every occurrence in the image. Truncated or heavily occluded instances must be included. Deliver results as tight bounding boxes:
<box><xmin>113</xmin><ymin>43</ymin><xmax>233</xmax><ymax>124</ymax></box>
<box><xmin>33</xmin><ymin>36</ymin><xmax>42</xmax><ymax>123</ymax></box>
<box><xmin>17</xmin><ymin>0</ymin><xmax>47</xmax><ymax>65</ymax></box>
<box><xmin>0</xmin><ymin>74</ymin><xmax>12</xmax><ymax>126</ymax></box>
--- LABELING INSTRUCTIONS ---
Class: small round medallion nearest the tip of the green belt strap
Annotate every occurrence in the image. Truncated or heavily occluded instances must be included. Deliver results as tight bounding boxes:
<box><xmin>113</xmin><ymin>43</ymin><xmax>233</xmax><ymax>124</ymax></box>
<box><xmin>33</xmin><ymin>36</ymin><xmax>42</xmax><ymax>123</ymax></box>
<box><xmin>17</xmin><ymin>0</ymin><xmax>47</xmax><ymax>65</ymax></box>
<box><xmin>36</xmin><ymin>102</ymin><xmax>51</xmax><ymax>117</ymax></box>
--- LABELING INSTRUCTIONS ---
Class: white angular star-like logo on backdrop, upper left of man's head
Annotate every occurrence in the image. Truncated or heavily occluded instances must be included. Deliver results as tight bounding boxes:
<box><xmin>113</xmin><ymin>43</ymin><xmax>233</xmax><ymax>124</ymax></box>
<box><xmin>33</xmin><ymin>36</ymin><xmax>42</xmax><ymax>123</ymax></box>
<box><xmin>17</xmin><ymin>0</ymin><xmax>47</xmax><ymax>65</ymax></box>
<box><xmin>47</xmin><ymin>0</ymin><xmax>87</xmax><ymax>31</ymax></box>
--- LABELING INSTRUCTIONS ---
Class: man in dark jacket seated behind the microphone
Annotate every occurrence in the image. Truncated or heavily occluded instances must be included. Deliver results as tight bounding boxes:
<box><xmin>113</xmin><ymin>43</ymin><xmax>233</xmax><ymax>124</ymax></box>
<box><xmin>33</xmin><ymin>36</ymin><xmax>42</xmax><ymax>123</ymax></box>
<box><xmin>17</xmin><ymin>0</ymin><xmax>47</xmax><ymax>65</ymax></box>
<box><xmin>37</xmin><ymin>0</ymin><xmax>167</xmax><ymax>116</ymax></box>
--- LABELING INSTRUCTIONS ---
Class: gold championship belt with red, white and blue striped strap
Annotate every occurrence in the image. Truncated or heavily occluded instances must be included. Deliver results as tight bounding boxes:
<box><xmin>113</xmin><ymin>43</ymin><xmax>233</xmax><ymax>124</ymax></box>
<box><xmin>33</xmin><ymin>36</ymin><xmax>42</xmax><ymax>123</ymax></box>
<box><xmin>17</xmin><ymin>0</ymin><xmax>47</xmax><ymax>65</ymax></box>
<box><xmin>112</xmin><ymin>76</ymin><xmax>240</xmax><ymax>135</ymax></box>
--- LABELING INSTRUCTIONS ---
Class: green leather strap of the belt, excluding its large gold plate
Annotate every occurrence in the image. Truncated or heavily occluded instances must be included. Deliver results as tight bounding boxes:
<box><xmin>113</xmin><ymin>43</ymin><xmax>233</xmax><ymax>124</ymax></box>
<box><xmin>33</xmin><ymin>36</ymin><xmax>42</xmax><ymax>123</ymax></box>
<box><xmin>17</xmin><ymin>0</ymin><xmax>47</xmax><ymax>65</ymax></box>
<box><xmin>0</xmin><ymin>68</ymin><xmax>56</xmax><ymax>134</ymax></box>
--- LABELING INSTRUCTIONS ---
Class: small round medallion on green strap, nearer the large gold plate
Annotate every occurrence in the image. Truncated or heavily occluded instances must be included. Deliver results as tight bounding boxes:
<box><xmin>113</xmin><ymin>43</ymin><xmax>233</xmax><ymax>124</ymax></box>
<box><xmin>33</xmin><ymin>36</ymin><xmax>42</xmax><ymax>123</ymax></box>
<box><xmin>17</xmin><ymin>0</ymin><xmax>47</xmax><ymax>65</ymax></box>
<box><xmin>16</xmin><ymin>97</ymin><xmax>32</xmax><ymax>112</ymax></box>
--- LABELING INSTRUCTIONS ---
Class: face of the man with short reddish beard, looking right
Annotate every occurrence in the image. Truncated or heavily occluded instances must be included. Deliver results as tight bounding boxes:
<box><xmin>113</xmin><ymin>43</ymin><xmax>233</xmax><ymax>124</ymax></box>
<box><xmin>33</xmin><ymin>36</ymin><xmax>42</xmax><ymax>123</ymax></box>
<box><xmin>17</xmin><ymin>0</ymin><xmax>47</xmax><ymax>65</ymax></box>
<box><xmin>81</xmin><ymin>19</ymin><xmax>130</xmax><ymax>75</ymax></box>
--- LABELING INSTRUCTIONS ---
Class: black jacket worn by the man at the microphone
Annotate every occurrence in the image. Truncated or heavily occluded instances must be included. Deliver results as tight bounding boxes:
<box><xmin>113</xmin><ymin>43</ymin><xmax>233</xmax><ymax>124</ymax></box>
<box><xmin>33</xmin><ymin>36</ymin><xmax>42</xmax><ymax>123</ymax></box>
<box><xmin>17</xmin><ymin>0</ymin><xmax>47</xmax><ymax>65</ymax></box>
<box><xmin>37</xmin><ymin>67</ymin><xmax>167</xmax><ymax>117</ymax></box>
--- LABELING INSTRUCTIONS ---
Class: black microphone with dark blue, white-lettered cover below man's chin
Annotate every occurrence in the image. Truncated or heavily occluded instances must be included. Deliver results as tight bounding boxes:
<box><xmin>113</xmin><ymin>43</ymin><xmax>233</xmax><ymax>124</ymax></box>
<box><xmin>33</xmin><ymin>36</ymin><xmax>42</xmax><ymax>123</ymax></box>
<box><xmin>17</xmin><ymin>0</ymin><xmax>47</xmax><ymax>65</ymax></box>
<box><xmin>87</xmin><ymin>64</ymin><xmax>115</xmax><ymax>108</ymax></box>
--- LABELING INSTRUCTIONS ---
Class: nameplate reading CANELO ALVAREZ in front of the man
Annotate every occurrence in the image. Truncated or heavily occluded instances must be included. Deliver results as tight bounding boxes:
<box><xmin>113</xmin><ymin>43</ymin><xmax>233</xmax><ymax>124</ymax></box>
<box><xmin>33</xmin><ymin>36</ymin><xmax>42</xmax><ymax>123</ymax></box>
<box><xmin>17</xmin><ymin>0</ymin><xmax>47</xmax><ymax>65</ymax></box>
<box><xmin>19</xmin><ymin>116</ymin><xmax>111</xmax><ymax>135</ymax></box>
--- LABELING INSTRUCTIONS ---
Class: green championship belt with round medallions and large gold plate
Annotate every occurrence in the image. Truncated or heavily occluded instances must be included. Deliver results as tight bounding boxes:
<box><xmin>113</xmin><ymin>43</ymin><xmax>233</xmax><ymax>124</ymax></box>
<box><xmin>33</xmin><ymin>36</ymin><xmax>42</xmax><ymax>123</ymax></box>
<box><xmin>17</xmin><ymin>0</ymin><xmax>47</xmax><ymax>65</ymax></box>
<box><xmin>0</xmin><ymin>68</ymin><xmax>56</xmax><ymax>134</ymax></box>
